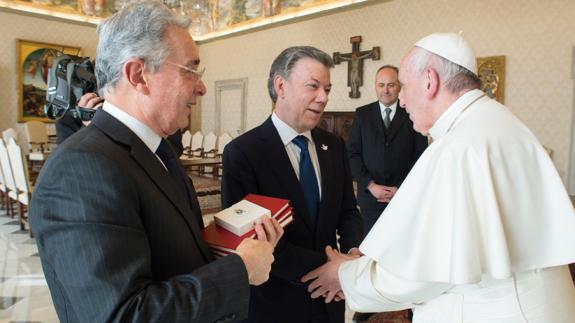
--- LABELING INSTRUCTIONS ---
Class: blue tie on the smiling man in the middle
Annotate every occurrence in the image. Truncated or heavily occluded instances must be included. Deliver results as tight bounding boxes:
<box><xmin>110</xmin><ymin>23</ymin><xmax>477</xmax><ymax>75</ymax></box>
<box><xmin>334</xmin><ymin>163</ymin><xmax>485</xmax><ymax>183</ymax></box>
<box><xmin>292</xmin><ymin>135</ymin><xmax>319</xmax><ymax>221</ymax></box>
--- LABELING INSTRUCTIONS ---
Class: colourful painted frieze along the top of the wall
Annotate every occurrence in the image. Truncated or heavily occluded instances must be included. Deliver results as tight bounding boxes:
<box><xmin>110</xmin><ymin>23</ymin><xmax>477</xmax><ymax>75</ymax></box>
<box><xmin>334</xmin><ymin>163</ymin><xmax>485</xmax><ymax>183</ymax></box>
<box><xmin>0</xmin><ymin>0</ymin><xmax>374</xmax><ymax>41</ymax></box>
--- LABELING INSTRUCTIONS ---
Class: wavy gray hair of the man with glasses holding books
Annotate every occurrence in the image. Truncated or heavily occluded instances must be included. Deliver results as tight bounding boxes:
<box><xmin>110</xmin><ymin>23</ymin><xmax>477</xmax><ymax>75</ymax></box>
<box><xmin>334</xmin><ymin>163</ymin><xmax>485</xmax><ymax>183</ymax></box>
<box><xmin>96</xmin><ymin>1</ymin><xmax>190</xmax><ymax>94</ymax></box>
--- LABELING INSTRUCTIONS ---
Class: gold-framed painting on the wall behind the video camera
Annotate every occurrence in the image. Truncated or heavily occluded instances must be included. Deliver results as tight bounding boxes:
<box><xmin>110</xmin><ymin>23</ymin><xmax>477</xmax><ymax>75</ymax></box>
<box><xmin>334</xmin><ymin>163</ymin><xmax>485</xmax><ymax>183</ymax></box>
<box><xmin>16</xmin><ymin>39</ymin><xmax>81</xmax><ymax>122</ymax></box>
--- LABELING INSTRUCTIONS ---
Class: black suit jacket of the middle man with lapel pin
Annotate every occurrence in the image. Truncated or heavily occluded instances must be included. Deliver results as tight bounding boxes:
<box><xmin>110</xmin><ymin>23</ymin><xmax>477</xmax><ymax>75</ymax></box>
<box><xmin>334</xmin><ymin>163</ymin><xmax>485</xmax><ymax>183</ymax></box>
<box><xmin>222</xmin><ymin>118</ymin><xmax>362</xmax><ymax>323</ymax></box>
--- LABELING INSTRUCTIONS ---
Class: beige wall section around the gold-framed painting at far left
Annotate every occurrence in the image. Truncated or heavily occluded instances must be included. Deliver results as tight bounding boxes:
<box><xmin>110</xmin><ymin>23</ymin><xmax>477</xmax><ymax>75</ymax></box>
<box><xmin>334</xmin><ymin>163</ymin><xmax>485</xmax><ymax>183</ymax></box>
<box><xmin>0</xmin><ymin>11</ymin><xmax>98</xmax><ymax>145</ymax></box>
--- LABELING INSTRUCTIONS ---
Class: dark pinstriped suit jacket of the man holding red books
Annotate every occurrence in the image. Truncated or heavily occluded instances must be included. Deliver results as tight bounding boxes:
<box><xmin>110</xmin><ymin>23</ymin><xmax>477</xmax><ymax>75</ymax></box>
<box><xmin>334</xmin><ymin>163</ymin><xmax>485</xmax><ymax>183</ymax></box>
<box><xmin>30</xmin><ymin>111</ymin><xmax>249</xmax><ymax>323</ymax></box>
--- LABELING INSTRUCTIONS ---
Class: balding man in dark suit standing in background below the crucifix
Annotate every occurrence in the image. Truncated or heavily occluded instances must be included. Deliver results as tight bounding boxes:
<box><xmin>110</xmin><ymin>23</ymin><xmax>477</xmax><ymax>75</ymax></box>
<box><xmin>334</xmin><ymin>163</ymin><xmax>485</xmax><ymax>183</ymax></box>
<box><xmin>347</xmin><ymin>65</ymin><xmax>427</xmax><ymax>234</ymax></box>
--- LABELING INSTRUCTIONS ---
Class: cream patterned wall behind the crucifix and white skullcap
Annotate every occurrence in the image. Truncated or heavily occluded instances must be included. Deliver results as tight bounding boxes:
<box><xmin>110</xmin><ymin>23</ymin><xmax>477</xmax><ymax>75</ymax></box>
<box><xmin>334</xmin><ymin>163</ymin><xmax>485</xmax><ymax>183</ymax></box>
<box><xmin>200</xmin><ymin>0</ymin><xmax>575</xmax><ymax>180</ymax></box>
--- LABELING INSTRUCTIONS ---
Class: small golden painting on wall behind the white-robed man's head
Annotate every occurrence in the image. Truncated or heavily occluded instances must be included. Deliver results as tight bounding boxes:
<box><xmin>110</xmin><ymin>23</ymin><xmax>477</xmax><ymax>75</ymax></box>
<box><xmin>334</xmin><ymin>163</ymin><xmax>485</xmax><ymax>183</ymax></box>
<box><xmin>477</xmin><ymin>56</ymin><xmax>505</xmax><ymax>104</ymax></box>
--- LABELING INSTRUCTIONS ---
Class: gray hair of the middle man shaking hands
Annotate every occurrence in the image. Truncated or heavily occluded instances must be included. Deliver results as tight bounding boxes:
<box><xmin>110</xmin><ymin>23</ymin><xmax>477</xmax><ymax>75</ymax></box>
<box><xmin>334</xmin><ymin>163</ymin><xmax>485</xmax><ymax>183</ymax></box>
<box><xmin>268</xmin><ymin>46</ymin><xmax>333</xmax><ymax>103</ymax></box>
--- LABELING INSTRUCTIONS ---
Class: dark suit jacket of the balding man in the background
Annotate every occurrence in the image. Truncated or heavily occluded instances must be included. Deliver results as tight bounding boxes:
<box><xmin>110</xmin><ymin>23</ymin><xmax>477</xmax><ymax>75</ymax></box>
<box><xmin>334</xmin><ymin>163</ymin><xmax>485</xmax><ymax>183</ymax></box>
<box><xmin>347</xmin><ymin>101</ymin><xmax>427</xmax><ymax>225</ymax></box>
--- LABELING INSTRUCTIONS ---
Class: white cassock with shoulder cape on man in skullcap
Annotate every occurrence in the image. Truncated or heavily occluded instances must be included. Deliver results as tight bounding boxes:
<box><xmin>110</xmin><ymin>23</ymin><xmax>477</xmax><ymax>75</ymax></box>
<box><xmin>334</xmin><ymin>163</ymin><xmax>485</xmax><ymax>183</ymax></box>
<box><xmin>339</xmin><ymin>90</ymin><xmax>575</xmax><ymax>323</ymax></box>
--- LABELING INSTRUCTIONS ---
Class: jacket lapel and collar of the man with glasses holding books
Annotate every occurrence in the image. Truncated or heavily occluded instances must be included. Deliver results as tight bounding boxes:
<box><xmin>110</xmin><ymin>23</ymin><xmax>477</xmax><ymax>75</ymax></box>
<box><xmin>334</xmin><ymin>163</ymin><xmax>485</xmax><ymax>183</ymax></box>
<box><xmin>92</xmin><ymin>110</ymin><xmax>211</xmax><ymax>260</ymax></box>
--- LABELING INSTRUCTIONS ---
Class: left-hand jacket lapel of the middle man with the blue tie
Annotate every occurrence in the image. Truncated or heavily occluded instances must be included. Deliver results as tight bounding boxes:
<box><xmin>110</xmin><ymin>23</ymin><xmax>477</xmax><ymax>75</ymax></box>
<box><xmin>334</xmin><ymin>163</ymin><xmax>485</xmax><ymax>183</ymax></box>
<box><xmin>259</xmin><ymin>118</ymin><xmax>315</xmax><ymax>232</ymax></box>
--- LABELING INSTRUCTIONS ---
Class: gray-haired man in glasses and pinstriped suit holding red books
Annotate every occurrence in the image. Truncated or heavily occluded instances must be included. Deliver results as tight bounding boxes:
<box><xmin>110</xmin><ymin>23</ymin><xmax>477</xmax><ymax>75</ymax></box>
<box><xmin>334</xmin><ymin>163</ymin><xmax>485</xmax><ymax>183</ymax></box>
<box><xmin>30</xmin><ymin>2</ymin><xmax>282</xmax><ymax>323</ymax></box>
